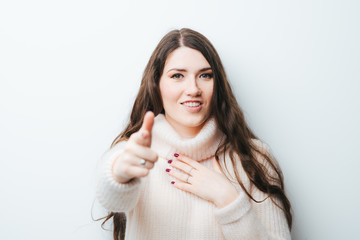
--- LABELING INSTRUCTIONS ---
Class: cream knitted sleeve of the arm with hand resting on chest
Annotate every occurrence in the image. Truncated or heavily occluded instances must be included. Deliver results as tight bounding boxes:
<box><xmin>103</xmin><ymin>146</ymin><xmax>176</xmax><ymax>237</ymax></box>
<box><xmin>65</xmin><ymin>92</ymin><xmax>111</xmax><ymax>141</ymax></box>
<box><xmin>214</xmin><ymin>141</ymin><xmax>291</xmax><ymax>240</ymax></box>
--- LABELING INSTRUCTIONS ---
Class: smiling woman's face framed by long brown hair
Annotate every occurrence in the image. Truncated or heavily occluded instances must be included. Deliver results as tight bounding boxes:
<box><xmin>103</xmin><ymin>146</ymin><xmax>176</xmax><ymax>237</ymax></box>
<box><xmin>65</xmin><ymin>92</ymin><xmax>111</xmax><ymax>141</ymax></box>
<box><xmin>159</xmin><ymin>47</ymin><xmax>214</xmax><ymax>138</ymax></box>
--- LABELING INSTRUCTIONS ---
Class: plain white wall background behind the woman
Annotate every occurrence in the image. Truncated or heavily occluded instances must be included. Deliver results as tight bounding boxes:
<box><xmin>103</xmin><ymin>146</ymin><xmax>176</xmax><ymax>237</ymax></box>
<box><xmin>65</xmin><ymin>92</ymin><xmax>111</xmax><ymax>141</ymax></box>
<box><xmin>0</xmin><ymin>0</ymin><xmax>360</xmax><ymax>240</ymax></box>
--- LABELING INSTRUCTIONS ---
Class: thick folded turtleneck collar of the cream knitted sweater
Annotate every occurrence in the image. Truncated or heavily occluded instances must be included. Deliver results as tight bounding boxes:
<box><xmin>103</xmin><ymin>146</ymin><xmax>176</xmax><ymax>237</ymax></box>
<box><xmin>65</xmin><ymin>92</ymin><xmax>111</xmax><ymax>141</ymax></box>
<box><xmin>151</xmin><ymin>114</ymin><xmax>223</xmax><ymax>161</ymax></box>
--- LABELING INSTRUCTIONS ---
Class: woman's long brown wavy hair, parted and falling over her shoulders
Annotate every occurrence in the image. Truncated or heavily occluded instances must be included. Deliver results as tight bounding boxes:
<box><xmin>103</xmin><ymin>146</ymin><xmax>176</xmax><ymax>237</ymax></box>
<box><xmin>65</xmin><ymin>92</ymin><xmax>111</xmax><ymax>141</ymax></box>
<box><xmin>97</xmin><ymin>28</ymin><xmax>292</xmax><ymax>240</ymax></box>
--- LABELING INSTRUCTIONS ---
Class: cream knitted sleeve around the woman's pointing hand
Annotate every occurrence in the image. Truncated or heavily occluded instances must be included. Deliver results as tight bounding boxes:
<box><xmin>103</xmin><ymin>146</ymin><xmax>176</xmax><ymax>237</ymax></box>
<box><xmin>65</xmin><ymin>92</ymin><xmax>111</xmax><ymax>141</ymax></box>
<box><xmin>96</xmin><ymin>142</ymin><xmax>141</xmax><ymax>212</ymax></box>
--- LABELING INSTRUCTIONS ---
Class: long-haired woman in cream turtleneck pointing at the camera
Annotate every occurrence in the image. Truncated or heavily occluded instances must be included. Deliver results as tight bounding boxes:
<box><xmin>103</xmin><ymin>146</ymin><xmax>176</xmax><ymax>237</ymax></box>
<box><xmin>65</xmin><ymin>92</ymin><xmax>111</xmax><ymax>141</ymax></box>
<box><xmin>97</xmin><ymin>29</ymin><xmax>292</xmax><ymax>240</ymax></box>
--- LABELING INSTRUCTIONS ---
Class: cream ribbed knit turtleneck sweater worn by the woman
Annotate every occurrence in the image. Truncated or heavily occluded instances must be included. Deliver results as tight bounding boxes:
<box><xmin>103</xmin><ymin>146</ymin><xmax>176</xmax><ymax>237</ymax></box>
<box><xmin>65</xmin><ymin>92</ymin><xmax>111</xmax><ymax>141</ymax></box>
<box><xmin>97</xmin><ymin>114</ymin><xmax>291</xmax><ymax>240</ymax></box>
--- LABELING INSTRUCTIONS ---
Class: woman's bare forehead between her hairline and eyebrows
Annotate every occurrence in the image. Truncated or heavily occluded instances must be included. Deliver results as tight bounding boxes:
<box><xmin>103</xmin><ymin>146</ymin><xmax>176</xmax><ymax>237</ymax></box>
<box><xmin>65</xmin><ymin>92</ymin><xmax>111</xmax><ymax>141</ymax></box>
<box><xmin>164</xmin><ymin>47</ymin><xmax>210</xmax><ymax>71</ymax></box>
